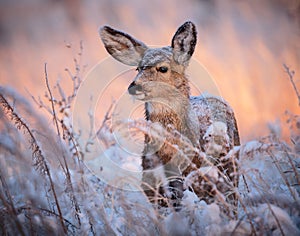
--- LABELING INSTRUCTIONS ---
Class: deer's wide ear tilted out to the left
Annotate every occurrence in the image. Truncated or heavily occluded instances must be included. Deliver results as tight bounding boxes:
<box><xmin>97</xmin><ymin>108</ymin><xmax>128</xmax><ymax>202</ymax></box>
<box><xmin>99</xmin><ymin>26</ymin><xmax>147</xmax><ymax>66</ymax></box>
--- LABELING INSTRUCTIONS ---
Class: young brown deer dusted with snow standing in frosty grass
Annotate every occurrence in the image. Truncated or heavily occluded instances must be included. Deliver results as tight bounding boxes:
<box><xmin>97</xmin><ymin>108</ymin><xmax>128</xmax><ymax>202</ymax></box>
<box><xmin>99</xmin><ymin>21</ymin><xmax>240</xmax><ymax>214</ymax></box>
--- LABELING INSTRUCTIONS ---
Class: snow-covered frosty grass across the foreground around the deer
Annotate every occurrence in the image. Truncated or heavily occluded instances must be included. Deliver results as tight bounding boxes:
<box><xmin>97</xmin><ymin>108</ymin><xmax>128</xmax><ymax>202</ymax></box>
<box><xmin>0</xmin><ymin>86</ymin><xmax>300</xmax><ymax>235</ymax></box>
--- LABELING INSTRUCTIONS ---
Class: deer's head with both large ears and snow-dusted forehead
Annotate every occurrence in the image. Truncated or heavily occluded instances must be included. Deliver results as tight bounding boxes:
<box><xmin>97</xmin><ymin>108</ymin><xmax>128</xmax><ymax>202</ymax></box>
<box><xmin>100</xmin><ymin>22</ymin><xmax>197</xmax><ymax>101</ymax></box>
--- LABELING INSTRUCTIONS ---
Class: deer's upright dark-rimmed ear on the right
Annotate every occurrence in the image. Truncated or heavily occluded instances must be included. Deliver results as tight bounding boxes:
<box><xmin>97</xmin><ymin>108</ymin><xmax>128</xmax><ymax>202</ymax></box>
<box><xmin>171</xmin><ymin>21</ymin><xmax>197</xmax><ymax>66</ymax></box>
